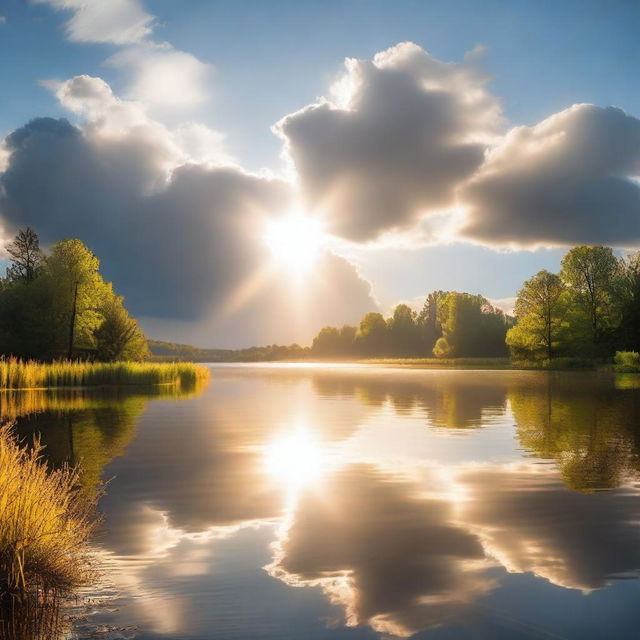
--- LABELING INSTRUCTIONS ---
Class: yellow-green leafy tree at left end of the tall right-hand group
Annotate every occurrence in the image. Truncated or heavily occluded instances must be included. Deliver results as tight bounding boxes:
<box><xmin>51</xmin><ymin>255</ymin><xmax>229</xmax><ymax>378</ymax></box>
<box><xmin>506</xmin><ymin>270</ymin><xmax>566</xmax><ymax>358</ymax></box>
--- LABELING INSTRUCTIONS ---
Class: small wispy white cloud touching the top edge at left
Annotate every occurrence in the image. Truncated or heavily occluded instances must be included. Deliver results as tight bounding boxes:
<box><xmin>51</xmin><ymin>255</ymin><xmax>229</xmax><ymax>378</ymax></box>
<box><xmin>34</xmin><ymin>0</ymin><xmax>154</xmax><ymax>44</ymax></box>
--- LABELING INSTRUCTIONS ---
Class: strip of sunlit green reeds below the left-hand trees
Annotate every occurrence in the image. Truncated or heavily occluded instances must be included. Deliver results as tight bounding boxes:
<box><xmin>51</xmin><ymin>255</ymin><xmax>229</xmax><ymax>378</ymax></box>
<box><xmin>0</xmin><ymin>358</ymin><xmax>209</xmax><ymax>389</ymax></box>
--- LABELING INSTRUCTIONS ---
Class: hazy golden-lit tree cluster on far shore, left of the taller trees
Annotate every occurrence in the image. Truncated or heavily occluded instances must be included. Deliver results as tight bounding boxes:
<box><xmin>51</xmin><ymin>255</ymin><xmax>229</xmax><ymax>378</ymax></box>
<box><xmin>311</xmin><ymin>291</ymin><xmax>514</xmax><ymax>358</ymax></box>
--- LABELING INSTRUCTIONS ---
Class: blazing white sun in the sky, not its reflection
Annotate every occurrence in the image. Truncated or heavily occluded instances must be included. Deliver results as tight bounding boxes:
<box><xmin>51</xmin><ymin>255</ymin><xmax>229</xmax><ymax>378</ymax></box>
<box><xmin>264</xmin><ymin>213</ymin><xmax>325</xmax><ymax>273</ymax></box>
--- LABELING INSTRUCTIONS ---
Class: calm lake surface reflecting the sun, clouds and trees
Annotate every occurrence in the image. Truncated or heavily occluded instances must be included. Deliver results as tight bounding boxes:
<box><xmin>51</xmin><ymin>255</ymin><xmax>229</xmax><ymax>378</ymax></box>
<box><xmin>7</xmin><ymin>366</ymin><xmax>640</xmax><ymax>640</ymax></box>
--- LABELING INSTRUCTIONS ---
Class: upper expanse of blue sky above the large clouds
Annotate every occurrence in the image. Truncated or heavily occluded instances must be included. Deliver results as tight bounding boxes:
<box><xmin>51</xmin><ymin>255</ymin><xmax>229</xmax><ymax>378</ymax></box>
<box><xmin>0</xmin><ymin>0</ymin><xmax>640</xmax><ymax>168</ymax></box>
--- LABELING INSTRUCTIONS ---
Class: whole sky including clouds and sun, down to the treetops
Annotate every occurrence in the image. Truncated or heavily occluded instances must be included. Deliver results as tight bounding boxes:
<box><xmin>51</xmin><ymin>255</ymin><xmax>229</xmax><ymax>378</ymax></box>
<box><xmin>0</xmin><ymin>0</ymin><xmax>640</xmax><ymax>347</ymax></box>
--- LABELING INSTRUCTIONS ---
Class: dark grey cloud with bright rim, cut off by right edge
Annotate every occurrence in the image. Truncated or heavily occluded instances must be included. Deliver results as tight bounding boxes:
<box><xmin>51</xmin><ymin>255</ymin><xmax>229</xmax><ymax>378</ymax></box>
<box><xmin>460</xmin><ymin>104</ymin><xmax>640</xmax><ymax>247</ymax></box>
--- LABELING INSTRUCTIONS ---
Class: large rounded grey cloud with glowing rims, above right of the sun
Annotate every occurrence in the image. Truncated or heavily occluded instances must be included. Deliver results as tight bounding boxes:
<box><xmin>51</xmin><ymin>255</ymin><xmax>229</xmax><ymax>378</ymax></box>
<box><xmin>275</xmin><ymin>42</ymin><xmax>501</xmax><ymax>241</ymax></box>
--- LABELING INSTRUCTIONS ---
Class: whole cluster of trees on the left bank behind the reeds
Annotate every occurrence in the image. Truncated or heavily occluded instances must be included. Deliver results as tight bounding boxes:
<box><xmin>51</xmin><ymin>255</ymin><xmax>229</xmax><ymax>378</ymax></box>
<box><xmin>0</xmin><ymin>227</ymin><xmax>148</xmax><ymax>362</ymax></box>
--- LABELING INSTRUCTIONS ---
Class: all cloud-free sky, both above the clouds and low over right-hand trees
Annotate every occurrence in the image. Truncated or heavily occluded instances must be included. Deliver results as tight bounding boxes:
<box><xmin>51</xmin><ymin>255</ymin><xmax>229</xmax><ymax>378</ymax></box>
<box><xmin>0</xmin><ymin>0</ymin><xmax>640</xmax><ymax>344</ymax></box>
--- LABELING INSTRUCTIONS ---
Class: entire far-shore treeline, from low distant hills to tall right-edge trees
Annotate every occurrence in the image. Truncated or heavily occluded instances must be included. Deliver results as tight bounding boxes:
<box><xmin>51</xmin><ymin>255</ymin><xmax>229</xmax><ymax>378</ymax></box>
<box><xmin>149</xmin><ymin>246</ymin><xmax>640</xmax><ymax>371</ymax></box>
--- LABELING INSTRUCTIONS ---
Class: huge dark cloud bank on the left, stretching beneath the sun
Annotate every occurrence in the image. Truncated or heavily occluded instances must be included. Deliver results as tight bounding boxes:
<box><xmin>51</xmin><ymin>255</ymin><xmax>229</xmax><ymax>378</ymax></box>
<box><xmin>0</xmin><ymin>76</ymin><xmax>374</xmax><ymax>345</ymax></box>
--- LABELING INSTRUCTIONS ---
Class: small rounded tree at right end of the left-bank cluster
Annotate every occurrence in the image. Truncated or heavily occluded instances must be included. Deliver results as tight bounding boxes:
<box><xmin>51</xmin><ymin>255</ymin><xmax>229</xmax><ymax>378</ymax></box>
<box><xmin>94</xmin><ymin>295</ymin><xmax>149</xmax><ymax>362</ymax></box>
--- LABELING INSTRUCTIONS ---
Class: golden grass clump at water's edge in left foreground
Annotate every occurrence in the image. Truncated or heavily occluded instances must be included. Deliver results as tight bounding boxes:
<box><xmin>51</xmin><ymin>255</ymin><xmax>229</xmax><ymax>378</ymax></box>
<box><xmin>0</xmin><ymin>424</ymin><xmax>98</xmax><ymax>637</ymax></box>
